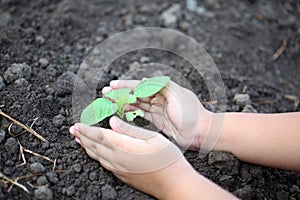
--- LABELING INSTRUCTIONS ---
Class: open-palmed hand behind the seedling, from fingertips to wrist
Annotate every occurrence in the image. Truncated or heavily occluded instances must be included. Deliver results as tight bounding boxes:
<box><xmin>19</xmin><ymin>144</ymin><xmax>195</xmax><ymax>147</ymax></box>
<box><xmin>102</xmin><ymin>80</ymin><xmax>211</xmax><ymax>150</ymax></box>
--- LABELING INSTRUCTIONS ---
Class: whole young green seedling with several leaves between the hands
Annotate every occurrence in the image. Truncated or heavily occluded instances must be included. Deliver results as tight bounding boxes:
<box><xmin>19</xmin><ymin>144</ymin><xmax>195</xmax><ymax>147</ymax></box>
<box><xmin>80</xmin><ymin>76</ymin><xmax>170</xmax><ymax>125</ymax></box>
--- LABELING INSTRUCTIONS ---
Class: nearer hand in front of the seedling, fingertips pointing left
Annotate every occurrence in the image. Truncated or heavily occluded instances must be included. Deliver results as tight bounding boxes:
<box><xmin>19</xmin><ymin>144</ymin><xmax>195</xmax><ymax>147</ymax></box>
<box><xmin>70</xmin><ymin>117</ymin><xmax>196</xmax><ymax>198</ymax></box>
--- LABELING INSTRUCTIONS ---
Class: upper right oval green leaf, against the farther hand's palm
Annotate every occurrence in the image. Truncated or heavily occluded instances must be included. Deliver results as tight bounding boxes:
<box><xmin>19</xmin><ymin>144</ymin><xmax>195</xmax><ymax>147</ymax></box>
<box><xmin>133</xmin><ymin>76</ymin><xmax>170</xmax><ymax>98</ymax></box>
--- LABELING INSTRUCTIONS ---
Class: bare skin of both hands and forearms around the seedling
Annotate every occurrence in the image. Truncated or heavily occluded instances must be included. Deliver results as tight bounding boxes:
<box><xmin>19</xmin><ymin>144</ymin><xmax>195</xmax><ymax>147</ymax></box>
<box><xmin>70</xmin><ymin>81</ymin><xmax>300</xmax><ymax>199</ymax></box>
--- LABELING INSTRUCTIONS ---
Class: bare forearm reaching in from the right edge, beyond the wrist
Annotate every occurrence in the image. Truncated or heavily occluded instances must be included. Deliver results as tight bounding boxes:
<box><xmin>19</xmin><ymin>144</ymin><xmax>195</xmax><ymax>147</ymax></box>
<box><xmin>215</xmin><ymin>112</ymin><xmax>300</xmax><ymax>171</ymax></box>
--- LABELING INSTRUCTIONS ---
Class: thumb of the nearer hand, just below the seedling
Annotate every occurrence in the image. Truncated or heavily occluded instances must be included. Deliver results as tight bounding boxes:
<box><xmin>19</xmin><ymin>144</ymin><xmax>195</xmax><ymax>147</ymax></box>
<box><xmin>109</xmin><ymin>116</ymin><xmax>158</xmax><ymax>139</ymax></box>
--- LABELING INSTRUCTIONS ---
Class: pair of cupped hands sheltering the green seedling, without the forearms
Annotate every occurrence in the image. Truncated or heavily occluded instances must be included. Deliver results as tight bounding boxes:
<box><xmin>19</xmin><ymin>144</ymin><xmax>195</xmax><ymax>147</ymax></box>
<box><xmin>70</xmin><ymin>80</ymin><xmax>211</xmax><ymax>198</ymax></box>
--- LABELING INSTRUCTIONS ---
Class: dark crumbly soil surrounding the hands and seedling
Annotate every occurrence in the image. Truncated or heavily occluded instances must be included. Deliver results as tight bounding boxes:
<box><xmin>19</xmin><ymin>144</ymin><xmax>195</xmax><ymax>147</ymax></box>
<box><xmin>0</xmin><ymin>0</ymin><xmax>300</xmax><ymax>199</ymax></box>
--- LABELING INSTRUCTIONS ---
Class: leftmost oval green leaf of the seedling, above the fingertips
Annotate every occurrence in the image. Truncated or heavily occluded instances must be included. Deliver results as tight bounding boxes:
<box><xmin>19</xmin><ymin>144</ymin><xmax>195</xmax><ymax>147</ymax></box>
<box><xmin>80</xmin><ymin>98</ymin><xmax>117</xmax><ymax>125</ymax></box>
